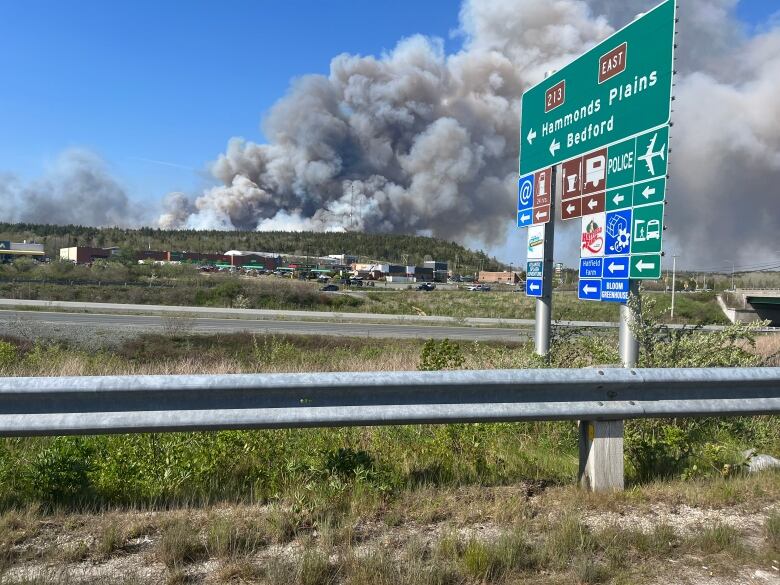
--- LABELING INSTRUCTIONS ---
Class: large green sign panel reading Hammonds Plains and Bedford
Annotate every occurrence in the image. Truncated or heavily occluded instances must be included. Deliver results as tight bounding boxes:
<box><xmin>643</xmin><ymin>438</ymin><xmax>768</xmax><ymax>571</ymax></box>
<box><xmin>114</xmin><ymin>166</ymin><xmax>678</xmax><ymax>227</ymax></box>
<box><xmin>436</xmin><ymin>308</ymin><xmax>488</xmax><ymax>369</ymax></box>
<box><xmin>520</xmin><ymin>0</ymin><xmax>676</xmax><ymax>175</ymax></box>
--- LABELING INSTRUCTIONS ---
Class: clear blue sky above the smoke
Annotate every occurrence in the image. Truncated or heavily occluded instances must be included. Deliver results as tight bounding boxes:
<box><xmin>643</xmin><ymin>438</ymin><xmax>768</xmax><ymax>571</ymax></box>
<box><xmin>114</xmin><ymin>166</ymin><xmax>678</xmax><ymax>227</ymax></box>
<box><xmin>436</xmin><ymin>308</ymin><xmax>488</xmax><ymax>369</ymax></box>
<box><xmin>0</xmin><ymin>0</ymin><xmax>780</xmax><ymax>214</ymax></box>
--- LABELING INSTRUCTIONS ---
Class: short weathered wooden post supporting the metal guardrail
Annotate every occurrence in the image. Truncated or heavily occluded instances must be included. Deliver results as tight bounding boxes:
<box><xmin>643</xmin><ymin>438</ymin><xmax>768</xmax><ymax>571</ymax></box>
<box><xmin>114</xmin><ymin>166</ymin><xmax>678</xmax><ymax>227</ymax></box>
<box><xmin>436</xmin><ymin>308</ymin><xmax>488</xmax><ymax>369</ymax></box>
<box><xmin>579</xmin><ymin>420</ymin><xmax>624</xmax><ymax>492</ymax></box>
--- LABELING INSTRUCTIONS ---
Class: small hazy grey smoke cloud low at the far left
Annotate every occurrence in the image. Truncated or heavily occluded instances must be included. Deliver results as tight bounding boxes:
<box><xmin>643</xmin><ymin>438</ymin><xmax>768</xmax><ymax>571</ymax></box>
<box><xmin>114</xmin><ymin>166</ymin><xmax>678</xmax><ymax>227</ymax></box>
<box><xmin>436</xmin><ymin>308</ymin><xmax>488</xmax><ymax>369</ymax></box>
<box><xmin>6</xmin><ymin>148</ymin><xmax>137</xmax><ymax>226</ymax></box>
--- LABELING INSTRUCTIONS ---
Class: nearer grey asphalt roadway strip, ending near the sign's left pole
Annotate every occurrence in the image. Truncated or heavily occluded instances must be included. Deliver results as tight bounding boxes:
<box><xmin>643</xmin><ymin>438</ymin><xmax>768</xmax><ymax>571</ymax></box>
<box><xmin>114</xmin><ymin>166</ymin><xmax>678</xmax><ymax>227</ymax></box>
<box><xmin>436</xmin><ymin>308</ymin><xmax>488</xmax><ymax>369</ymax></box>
<box><xmin>0</xmin><ymin>310</ymin><xmax>531</xmax><ymax>342</ymax></box>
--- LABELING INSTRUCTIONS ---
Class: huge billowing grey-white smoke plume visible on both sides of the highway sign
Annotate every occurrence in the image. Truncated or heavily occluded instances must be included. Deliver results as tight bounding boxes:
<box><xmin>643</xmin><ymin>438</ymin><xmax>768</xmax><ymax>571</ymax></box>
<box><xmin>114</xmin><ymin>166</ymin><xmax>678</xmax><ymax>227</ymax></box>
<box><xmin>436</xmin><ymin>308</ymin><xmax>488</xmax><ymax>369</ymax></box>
<box><xmin>160</xmin><ymin>0</ymin><xmax>780</xmax><ymax>263</ymax></box>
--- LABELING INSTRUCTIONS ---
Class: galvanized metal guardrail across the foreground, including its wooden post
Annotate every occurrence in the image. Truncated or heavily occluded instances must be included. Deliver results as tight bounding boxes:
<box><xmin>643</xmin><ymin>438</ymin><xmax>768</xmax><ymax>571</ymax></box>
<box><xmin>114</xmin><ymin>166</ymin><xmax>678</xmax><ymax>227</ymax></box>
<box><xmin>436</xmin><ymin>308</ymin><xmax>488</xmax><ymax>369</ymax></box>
<box><xmin>0</xmin><ymin>368</ymin><xmax>780</xmax><ymax>490</ymax></box>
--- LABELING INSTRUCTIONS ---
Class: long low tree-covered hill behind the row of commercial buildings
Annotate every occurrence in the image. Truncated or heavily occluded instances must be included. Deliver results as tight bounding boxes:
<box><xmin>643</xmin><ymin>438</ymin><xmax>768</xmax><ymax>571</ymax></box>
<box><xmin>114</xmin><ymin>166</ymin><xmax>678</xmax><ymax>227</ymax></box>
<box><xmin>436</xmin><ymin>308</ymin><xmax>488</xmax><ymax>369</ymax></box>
<box><xmin>0</xmin><ymin>223</ymin><xmax>501</xmax><ymax>272</ymax></box>
